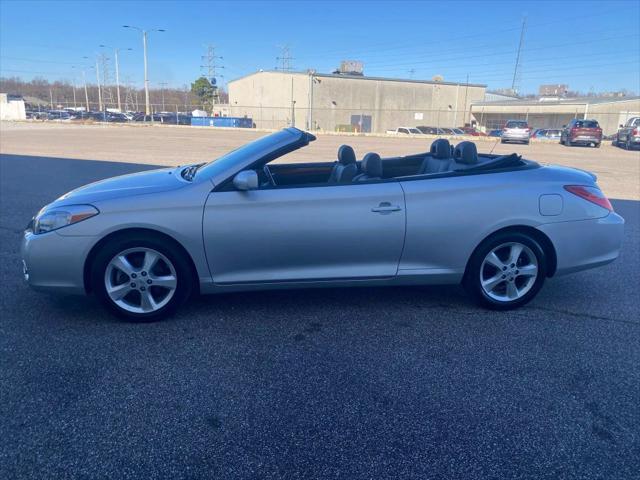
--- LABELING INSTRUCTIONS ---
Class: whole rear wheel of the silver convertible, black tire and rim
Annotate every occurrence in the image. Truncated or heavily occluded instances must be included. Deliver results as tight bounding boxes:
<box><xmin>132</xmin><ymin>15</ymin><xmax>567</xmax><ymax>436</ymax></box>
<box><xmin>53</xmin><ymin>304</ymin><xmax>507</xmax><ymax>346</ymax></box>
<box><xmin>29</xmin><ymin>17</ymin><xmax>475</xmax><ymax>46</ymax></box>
<box><xmin>463</xmin><ymin>232</ymin><xmax>547</xmax><ymax>310</ymax></box>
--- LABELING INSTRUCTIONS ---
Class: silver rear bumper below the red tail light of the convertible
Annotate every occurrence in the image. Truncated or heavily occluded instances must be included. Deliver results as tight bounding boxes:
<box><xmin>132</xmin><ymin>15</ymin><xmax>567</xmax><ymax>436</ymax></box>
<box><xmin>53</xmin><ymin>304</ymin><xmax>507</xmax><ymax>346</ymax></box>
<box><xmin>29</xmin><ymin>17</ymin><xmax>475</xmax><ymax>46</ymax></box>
<box><xmin>538</xmin><ymin>212</ymin><xmax>624</xmax><ymax>275</ymax></box>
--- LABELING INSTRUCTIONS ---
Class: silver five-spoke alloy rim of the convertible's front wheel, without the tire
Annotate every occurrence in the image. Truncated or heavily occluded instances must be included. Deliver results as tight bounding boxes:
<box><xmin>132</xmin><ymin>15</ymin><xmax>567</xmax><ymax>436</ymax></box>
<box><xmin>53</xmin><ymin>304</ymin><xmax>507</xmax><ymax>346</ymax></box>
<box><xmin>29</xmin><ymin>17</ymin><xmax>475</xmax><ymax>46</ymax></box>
<box><xmin>104</xmin><ymin>247</ymin><xmax>178</xmax><ymax>313</ymax></box>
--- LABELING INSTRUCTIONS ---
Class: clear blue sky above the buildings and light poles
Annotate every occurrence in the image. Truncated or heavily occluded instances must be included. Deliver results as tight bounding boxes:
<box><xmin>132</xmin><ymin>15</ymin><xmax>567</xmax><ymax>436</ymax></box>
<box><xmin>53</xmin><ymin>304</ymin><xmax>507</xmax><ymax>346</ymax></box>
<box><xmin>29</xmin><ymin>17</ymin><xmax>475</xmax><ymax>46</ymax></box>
<box><xmin>0</xmin><ymin>0</ymin><xmax>640</xmax><ymax>93</ymax></box>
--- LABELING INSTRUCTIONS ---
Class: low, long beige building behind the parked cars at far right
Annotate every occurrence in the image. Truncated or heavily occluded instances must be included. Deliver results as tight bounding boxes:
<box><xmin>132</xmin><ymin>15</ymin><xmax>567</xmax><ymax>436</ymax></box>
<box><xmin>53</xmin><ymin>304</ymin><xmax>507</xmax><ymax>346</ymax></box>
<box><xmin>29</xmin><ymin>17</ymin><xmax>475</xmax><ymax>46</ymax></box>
<box><xmin>471</xmin><ymin>97</ymin><xmax>640</xmax><ymax>135</ymax></box>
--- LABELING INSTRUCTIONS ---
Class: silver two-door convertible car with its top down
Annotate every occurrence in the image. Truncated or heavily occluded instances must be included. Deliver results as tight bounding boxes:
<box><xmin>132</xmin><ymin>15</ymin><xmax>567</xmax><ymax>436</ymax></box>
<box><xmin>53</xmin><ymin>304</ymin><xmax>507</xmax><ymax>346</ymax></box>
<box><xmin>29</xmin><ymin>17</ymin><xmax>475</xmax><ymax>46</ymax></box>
<box><xmin>22</xmin><ymin>128</ymin><xmax>624</xmax><ymax>321</ymax></box>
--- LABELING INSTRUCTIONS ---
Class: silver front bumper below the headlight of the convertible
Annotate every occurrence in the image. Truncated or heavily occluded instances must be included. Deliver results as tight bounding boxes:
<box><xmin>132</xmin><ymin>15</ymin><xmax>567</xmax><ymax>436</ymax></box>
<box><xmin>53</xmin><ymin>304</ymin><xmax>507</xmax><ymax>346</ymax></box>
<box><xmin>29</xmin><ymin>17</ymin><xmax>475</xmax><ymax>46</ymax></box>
<box><xmin>20</xmin><ymin>230</ymin><xmax>95</xmax><ymax>294</ymax></box>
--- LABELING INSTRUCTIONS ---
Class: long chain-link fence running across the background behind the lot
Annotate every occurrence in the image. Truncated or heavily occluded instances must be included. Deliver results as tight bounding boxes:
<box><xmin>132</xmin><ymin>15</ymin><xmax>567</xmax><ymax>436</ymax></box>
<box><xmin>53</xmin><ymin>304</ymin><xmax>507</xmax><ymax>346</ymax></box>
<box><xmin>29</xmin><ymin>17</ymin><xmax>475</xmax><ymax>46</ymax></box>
<box><xmin>22</xmin><ymin>102</ymin><xmax>640</xmax><ymax>135</ymax></box>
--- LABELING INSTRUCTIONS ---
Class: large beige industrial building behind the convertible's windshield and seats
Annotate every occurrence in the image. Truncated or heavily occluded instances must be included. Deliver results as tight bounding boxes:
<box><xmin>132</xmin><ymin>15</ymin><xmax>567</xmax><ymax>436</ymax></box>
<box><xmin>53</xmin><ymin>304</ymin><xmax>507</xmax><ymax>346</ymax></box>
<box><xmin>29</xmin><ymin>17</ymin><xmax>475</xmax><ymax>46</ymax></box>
<box><xmin>228</xmin><ymin>71</ymin><xmax>486</xmax><ymax>133</ymax></box>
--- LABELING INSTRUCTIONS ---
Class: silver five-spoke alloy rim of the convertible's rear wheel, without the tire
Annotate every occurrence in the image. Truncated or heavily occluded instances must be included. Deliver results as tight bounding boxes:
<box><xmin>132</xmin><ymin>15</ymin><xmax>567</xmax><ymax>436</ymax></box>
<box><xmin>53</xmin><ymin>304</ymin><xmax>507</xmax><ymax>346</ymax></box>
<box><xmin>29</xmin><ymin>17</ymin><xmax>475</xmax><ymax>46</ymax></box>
<box><xmin>480</xmin><ymin>242</ymin><xmax>538</xmax><ymax>302</ymax></box>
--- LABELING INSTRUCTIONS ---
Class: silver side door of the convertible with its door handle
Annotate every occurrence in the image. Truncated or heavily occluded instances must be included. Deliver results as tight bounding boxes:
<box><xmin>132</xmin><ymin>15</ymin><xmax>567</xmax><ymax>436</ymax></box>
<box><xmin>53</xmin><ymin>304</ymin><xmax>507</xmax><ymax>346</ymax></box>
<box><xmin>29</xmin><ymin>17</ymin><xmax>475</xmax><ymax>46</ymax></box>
<box><xmin>203</xmin><ymin>182</ymin><xmax>405</xmax><ymax>284</ymax></box>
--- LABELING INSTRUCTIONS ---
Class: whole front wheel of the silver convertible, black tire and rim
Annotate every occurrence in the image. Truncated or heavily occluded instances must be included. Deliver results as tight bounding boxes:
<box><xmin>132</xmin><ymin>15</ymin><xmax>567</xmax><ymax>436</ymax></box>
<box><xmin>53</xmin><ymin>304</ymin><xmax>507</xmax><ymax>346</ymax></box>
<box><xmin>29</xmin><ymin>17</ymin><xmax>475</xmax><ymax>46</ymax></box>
<box><xmin>91</xmin><ymin>233</ymin><xmax>194</xmax><ymax>322</ymax></box>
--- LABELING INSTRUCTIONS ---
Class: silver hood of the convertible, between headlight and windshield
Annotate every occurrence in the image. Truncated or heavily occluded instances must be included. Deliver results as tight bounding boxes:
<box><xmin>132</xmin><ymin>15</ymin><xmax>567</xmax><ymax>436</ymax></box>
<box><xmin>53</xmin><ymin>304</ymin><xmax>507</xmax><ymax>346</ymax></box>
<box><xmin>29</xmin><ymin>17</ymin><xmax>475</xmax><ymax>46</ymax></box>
<box><xmin>56</xmin><ymin>168</ymin><xmax>188</xmax><ymax>204</ymax></box>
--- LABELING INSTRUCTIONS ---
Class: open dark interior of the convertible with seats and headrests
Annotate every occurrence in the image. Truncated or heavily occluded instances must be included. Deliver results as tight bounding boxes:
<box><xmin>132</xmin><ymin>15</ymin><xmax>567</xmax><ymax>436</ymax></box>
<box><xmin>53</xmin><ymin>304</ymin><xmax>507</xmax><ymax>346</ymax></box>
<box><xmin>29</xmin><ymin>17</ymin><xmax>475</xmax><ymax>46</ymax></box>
<box><xmin>245</xmin><ymin>138</ymin><xmax>537</xmax><ymax>189</ymax></box>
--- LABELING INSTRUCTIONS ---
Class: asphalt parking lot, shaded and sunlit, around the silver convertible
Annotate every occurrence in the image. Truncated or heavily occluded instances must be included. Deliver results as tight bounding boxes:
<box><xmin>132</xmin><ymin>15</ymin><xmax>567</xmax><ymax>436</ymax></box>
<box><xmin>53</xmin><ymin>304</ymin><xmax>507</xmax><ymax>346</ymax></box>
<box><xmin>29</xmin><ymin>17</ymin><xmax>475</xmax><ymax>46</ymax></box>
<box><xmin>0</xmin><ymin>125</ymin><xmax>640</xmax><ymax>479</ymax></box>
